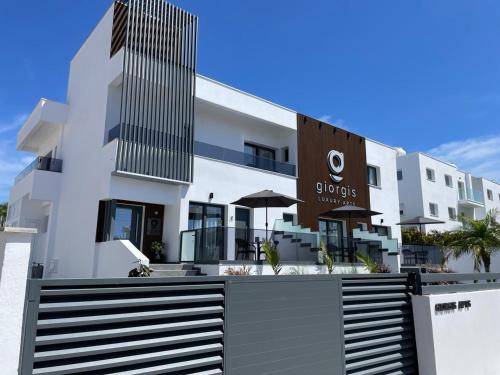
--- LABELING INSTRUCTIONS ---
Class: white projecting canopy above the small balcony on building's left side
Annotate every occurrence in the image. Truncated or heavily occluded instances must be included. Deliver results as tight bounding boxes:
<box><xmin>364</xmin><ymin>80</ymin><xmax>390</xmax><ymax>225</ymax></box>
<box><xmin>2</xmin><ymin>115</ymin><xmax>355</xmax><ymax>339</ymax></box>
<box><xmin>17</xmin><ymin>99</ymin><xmax>68</xmax><ymax>153</ymax></box>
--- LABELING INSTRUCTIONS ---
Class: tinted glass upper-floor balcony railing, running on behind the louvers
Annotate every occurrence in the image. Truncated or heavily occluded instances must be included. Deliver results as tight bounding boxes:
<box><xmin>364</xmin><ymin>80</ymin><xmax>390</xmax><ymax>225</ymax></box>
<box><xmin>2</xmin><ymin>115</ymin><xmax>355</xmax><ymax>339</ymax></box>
<box><xmin>108</xmin><ymin>125</ymin><xmax>295</xmax><ymax>176</ymax></box>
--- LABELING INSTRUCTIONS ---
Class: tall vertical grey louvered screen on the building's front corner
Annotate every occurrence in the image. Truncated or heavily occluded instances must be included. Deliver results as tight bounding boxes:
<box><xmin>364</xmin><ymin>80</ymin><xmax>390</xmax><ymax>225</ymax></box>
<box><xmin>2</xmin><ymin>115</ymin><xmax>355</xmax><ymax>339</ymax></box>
<box><xmin>110</xmin><ymin>0</ymin><xmax>198</xmax><ymax>182</ymax></box>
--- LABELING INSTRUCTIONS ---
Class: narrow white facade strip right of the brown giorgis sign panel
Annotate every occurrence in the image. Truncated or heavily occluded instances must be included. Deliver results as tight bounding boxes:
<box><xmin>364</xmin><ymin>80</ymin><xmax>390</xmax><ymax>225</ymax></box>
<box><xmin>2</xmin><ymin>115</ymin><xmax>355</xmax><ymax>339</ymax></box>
<box><xmin>366</xmin><ymin>140</ymin><xmax>401</xmax><ymax>242</ymax></box>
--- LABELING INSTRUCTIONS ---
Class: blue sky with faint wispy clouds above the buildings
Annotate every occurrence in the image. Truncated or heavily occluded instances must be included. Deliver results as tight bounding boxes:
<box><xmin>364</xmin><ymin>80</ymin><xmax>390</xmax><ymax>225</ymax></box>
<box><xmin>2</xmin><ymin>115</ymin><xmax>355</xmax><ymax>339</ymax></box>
<box><xmin>0</xmin><ymin>0</ymin><xmax>500</xmax><ymax>201</ymax></box>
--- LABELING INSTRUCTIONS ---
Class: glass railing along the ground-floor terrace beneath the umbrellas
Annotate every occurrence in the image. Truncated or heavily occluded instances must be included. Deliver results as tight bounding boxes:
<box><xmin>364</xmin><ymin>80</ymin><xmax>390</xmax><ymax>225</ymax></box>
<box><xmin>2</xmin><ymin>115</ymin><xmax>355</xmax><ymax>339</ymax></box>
<box><xmin>180</xmin><ymin>227</ymin><xmax>382</xmax><ymax>264</ymax></box>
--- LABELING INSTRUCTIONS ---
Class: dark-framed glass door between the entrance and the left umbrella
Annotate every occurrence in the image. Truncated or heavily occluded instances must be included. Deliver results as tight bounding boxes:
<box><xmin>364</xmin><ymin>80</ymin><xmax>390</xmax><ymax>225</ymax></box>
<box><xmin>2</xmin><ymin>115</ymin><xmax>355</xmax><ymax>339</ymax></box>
<box><xmin>188</xmin><ymin>203</ymin><xmax>225</xmax><ymax>261</ymax></box>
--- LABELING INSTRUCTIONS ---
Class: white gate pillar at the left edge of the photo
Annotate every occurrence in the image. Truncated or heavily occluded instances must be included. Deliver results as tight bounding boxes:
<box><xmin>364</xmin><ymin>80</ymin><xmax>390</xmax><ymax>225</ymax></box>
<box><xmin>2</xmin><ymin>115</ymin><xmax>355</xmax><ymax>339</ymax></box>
<box><xmin>0</xmin><ymin>228</ymin><xmax>36</xmax><ymax>374</ymax></box>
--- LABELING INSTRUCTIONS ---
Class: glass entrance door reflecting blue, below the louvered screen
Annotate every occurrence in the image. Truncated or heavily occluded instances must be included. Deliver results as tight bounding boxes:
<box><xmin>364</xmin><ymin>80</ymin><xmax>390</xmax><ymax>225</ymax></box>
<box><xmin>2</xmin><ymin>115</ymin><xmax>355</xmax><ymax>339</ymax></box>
<box><xmin>113</xmin><ymin>203</ymin><xmax>143</xmax><ymax>250</ymax></box>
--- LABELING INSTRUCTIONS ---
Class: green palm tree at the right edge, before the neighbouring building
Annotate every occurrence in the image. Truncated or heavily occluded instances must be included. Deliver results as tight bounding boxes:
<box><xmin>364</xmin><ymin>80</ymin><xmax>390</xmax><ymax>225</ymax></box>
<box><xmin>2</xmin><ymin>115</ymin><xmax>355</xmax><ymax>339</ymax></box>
<box><xmin>448</xmin><ymin>210</ymin><xmax>500</xmax><ymax>272</ymax></box>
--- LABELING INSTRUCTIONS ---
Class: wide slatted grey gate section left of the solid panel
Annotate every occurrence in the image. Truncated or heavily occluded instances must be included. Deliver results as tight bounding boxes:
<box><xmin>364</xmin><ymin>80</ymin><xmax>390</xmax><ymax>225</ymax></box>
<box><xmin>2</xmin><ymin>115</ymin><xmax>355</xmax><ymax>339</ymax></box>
<box><xmin>21</xmin><ymin>277</ymin><xmax>225</xmax><ymax>375</ymax></box>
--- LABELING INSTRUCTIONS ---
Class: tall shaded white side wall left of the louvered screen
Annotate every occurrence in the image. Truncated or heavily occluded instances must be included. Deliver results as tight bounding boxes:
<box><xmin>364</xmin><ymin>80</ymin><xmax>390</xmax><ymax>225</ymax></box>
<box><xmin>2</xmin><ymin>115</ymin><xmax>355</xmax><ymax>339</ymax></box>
<box><xmin>46</xmin><ymin>7</ymin><xmax>116</xmax><ymax>277</ymax></box>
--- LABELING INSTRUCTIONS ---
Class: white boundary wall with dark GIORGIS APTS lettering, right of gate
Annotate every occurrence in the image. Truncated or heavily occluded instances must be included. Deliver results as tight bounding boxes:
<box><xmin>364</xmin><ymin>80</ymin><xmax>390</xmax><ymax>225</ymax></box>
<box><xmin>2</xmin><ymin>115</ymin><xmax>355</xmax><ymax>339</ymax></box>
<box><xmin>412</xmin><ymin>290</ymin><xmax>500</xmax><ymax>375</ymax></box>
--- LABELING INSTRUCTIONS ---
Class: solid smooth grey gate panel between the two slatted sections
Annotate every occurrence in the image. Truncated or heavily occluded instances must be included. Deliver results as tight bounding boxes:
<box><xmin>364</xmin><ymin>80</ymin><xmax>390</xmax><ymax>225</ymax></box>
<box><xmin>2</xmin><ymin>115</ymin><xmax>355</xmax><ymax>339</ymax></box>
<box><xmin>224</xmin><ymin>276</ymin><xmax>344</xmax><ymax>375</ymax></box>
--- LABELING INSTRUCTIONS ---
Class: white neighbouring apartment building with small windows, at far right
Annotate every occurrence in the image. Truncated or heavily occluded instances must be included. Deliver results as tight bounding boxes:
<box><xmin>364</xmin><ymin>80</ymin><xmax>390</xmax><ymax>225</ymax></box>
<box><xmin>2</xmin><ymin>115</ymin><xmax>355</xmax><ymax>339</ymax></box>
<box><xmin>397</xmin><ymin>150</ymin><xmax>500</xmax><ymax>231</ymax></box>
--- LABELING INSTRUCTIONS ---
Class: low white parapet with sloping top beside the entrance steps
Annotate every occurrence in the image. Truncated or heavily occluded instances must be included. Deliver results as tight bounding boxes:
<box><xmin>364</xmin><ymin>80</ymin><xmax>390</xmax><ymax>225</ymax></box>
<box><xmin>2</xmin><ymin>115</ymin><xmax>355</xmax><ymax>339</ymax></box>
<box><xmin>94</xmin><ymin>240</ymin><xmax>149</xmax><ymax>278</ymax></box>
